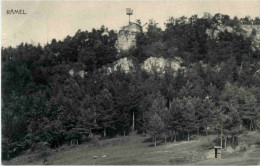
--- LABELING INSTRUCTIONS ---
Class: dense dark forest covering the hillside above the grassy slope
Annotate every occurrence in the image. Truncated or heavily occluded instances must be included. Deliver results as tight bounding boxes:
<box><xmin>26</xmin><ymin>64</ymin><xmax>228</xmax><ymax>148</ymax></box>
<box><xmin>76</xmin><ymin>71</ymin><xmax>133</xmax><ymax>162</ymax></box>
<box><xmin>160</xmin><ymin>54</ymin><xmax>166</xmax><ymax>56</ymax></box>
<box><xmin>1</xmin><ymin>13</ymin><xmax>260</xmax><ymax>159</ymax></box>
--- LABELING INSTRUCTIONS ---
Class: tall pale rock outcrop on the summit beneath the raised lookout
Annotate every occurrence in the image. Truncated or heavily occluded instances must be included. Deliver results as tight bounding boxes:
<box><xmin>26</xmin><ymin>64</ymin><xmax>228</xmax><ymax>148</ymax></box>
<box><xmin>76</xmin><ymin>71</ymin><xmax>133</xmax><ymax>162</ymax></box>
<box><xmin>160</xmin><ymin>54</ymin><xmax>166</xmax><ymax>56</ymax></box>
<box><xmin>116</xmin><ymin>22</ymin><xmax>142</xmax><ymax>52</ymax></box>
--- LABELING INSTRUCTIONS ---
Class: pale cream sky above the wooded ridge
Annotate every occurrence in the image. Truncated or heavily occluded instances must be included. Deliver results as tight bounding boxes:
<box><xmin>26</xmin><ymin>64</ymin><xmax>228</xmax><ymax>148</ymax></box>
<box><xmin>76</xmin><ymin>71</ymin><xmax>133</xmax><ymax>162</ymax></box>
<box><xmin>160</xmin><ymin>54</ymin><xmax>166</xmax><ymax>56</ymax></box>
<box><xmin>1</xmin><ymin>0</ymin><xmax>260</xmax><ymax>47</ymax></box>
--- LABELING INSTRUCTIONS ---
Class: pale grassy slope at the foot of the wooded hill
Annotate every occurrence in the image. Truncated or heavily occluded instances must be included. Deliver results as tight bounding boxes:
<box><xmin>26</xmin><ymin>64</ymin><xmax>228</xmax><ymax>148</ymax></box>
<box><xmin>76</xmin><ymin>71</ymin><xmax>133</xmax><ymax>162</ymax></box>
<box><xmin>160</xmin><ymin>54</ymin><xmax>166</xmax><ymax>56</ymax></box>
<box><xmin>3</xmin><ymin>132</ymin><xmax>260</xmax><ymax>165</ymax></box>
